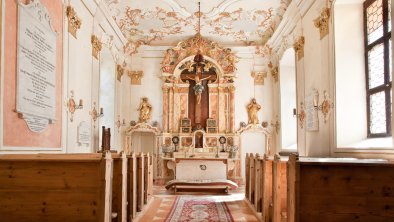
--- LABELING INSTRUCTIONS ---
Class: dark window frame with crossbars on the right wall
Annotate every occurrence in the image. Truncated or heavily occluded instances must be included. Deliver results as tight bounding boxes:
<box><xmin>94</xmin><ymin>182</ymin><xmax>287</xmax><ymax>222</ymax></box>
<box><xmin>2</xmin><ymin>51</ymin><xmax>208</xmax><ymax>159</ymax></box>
<box><xmin>363</xmin><ymin>0</ymin><xmax>392</xmax><ymax>138</ymax></box>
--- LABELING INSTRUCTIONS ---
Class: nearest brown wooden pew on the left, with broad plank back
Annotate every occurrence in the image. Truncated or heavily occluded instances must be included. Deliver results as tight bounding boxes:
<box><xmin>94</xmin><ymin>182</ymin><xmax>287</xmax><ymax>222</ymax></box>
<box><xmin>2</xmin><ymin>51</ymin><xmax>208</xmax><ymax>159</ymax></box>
<box><xmin>0</xmin><ymin>152</ymin><xmax>113</xmax><ymax>222</ymax></box>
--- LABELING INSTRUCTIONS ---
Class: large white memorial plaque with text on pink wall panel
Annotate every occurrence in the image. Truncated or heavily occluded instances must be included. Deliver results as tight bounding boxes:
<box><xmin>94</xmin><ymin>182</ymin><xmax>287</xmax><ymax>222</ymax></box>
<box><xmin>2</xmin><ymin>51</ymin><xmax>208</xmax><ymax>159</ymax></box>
<box><xmin>16</xmin><ymin>0</ymin><xmax>57</xmax><ymax>132</ymax></box>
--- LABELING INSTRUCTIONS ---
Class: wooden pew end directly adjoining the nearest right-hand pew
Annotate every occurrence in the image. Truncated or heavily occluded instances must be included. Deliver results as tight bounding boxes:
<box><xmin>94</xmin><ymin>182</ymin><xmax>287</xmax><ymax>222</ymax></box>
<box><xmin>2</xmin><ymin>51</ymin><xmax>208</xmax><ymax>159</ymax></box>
<box><xmin>272</xmin><ymin>154</ymin><xmax>287</xmax><ymax>222</ymax></box>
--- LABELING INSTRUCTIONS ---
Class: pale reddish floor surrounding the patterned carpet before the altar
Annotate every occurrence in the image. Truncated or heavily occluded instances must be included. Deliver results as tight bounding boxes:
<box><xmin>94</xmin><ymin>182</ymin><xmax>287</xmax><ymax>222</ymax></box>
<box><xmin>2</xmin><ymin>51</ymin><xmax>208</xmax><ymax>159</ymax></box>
<box><xmin>135</xmin><ymin>187</ymin><xmax>259</xmax><ymax>222</ymax></box>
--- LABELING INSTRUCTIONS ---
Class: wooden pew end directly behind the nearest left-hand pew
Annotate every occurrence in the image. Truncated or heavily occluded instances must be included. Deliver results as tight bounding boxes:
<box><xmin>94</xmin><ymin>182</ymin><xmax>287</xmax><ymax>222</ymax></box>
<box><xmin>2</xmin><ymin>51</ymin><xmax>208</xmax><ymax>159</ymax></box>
<box><xmin>112</xmin><ymin>152</ymin><xmax>128</xmax><ymax>222</ymax></box>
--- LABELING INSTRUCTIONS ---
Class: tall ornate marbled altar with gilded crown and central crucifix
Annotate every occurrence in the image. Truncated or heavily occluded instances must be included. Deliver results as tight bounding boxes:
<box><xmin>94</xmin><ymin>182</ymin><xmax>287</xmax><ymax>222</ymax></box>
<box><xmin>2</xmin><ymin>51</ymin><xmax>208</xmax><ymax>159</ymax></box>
<box><xmin>157</xmin><ymin>34</ymin><xmax>241</xmax><ymax>183</ymax></box>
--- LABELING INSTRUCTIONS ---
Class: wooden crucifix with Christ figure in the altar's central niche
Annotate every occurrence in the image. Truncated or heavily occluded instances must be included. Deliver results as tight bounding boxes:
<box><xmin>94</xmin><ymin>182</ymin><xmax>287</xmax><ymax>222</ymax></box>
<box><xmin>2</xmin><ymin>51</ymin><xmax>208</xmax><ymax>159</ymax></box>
<box><xmin>181</xmin><ymin>64</ymin><xmax>217</xmax><ymax>129</ymax></box>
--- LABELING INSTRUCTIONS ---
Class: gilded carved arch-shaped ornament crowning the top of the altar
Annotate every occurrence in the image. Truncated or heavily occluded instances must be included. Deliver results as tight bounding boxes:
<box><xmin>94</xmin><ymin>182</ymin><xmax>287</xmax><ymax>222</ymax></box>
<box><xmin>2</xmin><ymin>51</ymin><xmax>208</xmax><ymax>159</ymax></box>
<box><xmin>161</xmin><ymin>34</ymin><xmax>239</xmax><ymax>74</ymax></box>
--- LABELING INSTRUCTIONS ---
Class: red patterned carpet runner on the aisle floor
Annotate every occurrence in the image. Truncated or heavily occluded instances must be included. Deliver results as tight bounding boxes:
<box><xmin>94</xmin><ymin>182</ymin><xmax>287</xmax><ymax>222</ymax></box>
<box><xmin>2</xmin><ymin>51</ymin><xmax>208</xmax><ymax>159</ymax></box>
<box><xmin>165</xmin><ymin>196</ymin><xmax>234</xmax><ymax>222</ymax></box>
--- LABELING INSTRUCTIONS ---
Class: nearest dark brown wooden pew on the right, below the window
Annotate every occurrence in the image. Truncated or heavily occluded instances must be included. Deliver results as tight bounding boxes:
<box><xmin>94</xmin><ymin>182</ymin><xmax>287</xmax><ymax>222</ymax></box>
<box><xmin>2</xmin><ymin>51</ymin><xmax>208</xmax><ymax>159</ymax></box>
<box><xmin>288</xmin><ymin>155</ymin><xmax>394</xmax><ymax>222</ymax></box>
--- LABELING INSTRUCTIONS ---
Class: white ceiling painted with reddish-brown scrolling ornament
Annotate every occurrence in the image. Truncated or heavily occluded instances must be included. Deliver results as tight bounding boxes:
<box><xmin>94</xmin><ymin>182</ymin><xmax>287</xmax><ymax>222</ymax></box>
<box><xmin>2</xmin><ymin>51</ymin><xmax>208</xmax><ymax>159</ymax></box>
<box><xmin>105</xmin><ymin>0</ymin><xmax>291</xmax><ymax>54</ymax></box>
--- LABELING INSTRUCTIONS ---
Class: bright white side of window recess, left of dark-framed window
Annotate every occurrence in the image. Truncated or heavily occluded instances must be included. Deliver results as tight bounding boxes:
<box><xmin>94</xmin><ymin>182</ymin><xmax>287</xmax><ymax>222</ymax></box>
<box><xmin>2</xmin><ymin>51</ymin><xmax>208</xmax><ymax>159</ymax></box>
<box><xmin>334</xmin><ymin>3</ymin><xmax>367</xmax><ymax>147</ymax></box>
